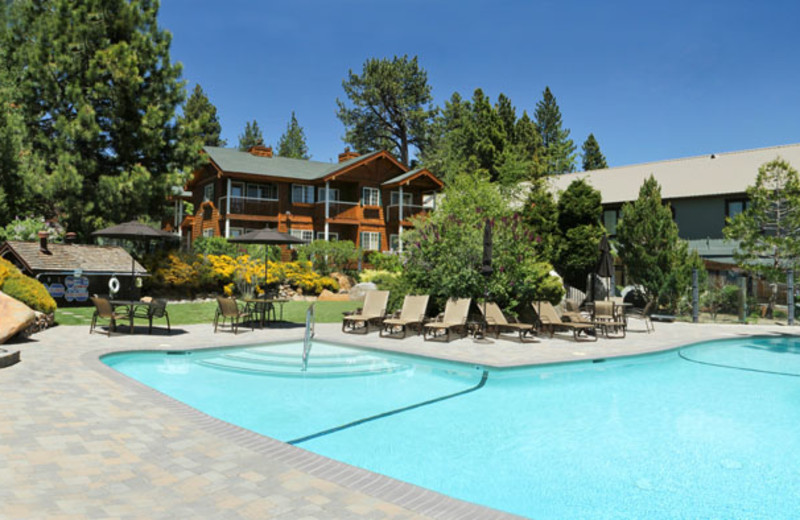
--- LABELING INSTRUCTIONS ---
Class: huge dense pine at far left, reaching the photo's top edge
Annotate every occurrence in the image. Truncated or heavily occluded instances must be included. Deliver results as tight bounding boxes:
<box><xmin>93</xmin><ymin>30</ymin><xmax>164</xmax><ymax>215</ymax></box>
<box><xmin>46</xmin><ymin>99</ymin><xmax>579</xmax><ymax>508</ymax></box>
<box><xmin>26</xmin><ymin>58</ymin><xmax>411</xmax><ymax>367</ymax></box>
<box><xmin>0</xmin><ymin>0</ymin><xmax>185</xmax><ymax>236</ymax></box>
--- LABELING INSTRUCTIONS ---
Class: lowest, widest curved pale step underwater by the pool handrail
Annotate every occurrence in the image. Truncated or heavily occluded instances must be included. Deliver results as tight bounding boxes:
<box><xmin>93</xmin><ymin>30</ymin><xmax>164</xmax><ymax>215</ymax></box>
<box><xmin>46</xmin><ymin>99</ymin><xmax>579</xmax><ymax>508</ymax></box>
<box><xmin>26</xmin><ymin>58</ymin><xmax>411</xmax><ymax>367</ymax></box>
<box><xmin>198</xmin><ymin>355</ymin><xmax>411</xmax><ymax>377</ymax></box>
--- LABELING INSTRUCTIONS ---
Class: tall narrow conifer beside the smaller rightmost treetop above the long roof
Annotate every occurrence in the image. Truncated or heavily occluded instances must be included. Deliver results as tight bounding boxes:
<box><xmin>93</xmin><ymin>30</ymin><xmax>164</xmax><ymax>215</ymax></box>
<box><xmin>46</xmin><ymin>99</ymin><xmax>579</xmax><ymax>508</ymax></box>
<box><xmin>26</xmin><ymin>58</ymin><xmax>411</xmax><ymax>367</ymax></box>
<box><xmin>535</xmin><ymin>87</ymin><xmax>575</xmax><ymax>173</ymax></box>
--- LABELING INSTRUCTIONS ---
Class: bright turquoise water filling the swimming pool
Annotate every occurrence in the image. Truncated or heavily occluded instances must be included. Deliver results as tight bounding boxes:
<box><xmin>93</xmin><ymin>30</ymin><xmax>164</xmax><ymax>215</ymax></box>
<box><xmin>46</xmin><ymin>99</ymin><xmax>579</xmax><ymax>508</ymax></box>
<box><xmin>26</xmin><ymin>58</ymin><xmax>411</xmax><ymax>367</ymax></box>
<box><xmin>103</xmin><ymin>338</ymin><xmax>800</xmax><ymax>519</ymax></box>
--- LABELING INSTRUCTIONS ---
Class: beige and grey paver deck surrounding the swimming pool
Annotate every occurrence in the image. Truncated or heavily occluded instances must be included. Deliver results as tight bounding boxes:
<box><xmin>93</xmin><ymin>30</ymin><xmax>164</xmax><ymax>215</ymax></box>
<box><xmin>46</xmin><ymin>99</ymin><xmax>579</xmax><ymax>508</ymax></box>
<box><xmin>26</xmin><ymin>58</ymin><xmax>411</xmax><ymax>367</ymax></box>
<box><xmin>0</xmin><ymin>323</ymin><xmax>798</xmax><ymax>519</ymax></box>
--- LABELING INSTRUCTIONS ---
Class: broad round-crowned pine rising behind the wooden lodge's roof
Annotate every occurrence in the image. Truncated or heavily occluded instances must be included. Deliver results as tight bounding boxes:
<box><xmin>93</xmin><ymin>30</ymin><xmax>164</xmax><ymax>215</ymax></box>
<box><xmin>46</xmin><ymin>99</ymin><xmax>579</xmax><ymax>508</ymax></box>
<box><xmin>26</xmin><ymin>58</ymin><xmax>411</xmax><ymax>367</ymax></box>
<box><xmin>336</xmin><ymin>56</ymin><xmax>436</xmax><ymax>164</ymax></box>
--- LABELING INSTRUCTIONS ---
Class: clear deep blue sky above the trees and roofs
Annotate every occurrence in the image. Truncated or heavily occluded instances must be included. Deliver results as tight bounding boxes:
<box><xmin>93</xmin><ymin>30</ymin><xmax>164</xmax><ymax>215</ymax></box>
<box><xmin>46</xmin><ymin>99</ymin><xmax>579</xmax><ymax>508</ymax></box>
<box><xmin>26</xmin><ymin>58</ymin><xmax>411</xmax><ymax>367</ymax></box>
<box><xmin>159</xmin><ymin>0</ymin><xmax>800</xmax><ymax>166</ymax></box>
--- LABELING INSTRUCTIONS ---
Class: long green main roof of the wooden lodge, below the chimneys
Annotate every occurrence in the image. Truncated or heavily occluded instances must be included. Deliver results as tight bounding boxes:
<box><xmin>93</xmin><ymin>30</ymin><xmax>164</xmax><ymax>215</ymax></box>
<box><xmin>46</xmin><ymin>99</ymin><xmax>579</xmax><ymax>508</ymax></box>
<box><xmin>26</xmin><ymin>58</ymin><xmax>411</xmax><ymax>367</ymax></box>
<box><xmin>203</xmin><ymin>146</ymin><xmax>380</xmax><ymax>181</ymax></box>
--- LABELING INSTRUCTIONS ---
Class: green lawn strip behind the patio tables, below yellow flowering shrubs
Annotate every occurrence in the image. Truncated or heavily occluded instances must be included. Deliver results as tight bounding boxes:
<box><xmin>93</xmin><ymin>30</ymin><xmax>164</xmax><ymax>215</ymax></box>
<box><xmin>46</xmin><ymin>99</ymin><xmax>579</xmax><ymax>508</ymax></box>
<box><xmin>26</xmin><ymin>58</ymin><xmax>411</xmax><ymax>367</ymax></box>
<box><xmin>56</xmin><ymin>301</ymin><xmax>362</xmax><ymax>325</ymax></box>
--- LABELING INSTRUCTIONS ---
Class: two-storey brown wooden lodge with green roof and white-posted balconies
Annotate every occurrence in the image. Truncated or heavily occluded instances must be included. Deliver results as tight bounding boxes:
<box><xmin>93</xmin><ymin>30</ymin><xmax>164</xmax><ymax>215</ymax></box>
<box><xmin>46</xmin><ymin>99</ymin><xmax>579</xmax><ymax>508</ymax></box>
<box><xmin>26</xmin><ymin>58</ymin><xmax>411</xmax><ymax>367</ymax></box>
<box><xmin>179</xmin><ymin>146</ymin><xmax>442</xmax><ymax>251</ymax></box>
